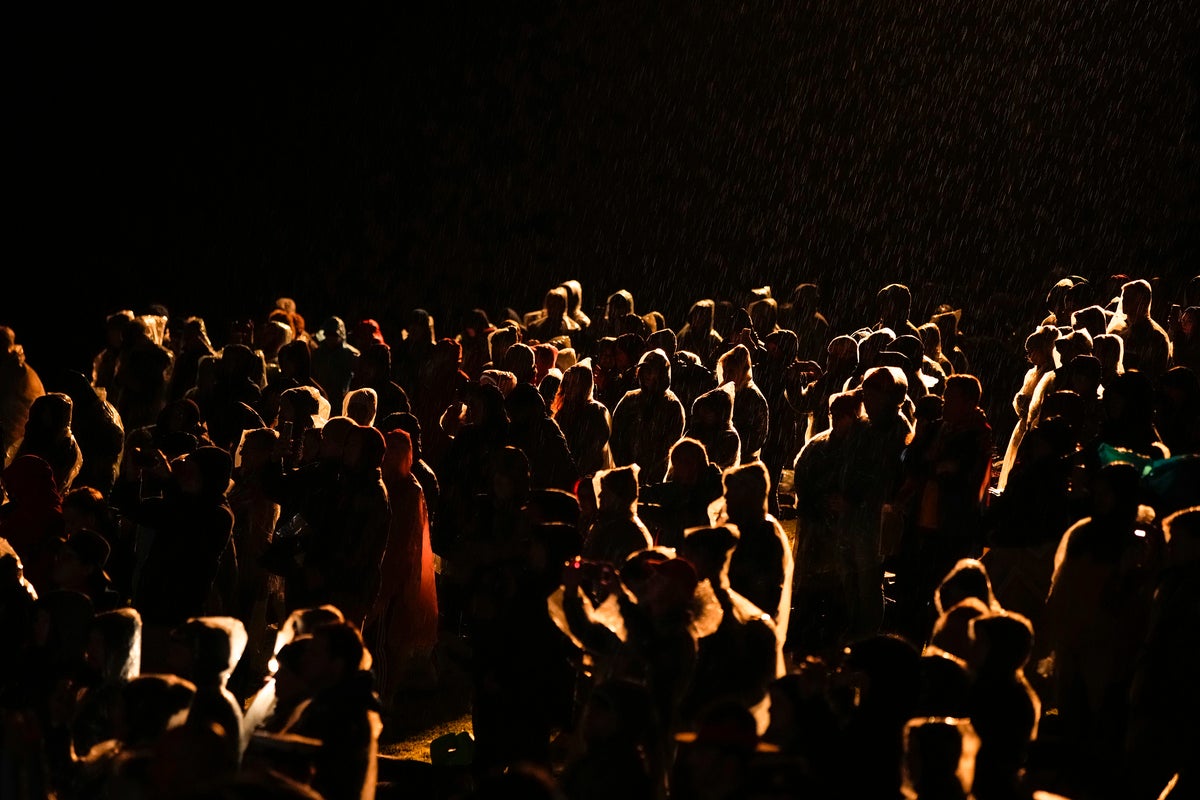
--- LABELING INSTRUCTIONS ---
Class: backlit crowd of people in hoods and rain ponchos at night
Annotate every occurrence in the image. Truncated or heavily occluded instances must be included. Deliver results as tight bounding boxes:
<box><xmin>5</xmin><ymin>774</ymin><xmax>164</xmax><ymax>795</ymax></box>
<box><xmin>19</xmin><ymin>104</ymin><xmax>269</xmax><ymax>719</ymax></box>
<box><xmin>0</xmin><ymin>276</ymin><xmax>1200</xmax><ymax>800</ymax></box>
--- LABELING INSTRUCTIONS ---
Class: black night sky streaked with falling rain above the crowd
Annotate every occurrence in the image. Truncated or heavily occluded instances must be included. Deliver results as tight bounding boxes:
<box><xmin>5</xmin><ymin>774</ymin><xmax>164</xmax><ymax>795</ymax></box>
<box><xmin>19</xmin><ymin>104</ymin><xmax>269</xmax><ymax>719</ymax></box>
<box><xmin>9</xmin><ymin>0</ymin><xmax>1200</xmax><ymax>376</ymax></box>
